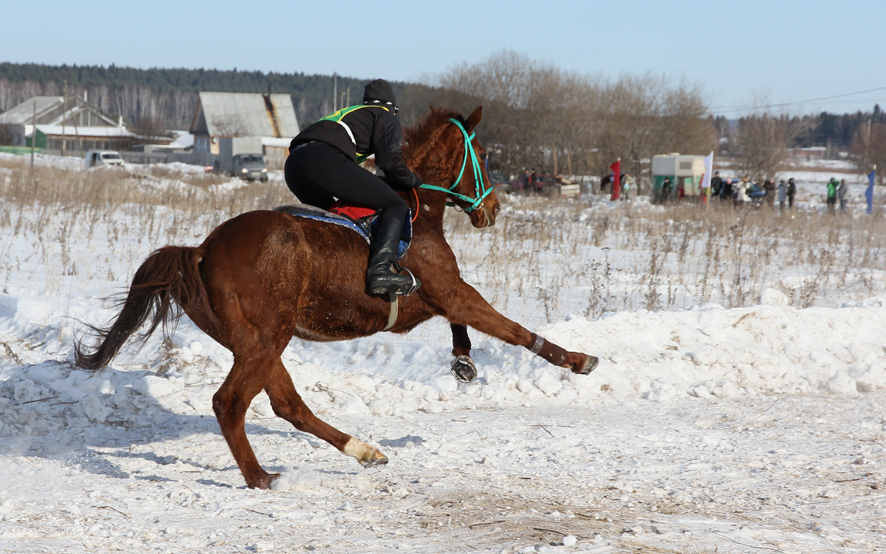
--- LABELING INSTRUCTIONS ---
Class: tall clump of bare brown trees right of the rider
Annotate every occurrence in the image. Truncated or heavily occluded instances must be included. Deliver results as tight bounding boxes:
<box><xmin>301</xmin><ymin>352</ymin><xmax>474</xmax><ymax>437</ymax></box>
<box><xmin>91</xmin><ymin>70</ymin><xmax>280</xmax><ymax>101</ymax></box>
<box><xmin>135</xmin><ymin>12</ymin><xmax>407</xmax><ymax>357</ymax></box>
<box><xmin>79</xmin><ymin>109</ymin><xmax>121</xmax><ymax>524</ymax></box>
<box><xmin>441</xmin><ymin>51</ymin><xmax>716</xmax><ymax>189</ymax></box>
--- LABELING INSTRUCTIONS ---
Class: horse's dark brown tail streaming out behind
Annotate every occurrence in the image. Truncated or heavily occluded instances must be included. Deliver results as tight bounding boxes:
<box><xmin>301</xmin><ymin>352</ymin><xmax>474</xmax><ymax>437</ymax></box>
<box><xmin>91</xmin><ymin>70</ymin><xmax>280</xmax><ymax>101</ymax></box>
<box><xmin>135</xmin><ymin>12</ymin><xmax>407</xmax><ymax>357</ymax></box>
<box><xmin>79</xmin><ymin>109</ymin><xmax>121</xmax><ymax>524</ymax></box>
<box><xmin>74</xmin><ymin>246</ymin><xmax>215</xmax><ymax>370</ymax></box>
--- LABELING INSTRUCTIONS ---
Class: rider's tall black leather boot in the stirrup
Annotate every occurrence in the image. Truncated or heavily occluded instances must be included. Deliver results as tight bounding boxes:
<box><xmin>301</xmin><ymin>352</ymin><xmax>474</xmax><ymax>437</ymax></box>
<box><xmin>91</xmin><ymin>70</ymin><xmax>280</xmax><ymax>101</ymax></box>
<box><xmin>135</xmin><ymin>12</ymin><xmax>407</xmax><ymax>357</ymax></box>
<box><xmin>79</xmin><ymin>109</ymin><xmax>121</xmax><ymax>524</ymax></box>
<box><xmin>366</xmin><ymin>216</ymin><xmax>421</xmax><ymax>296</ymax></box>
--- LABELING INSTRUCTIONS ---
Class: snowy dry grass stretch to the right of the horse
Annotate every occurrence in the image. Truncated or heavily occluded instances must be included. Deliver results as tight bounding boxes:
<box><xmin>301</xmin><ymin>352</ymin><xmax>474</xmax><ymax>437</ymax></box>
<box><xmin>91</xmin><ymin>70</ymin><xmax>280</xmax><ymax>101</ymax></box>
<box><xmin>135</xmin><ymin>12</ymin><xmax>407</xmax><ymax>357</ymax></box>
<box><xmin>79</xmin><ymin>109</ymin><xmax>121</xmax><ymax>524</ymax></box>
<box><xmin>449</xmin><ymin>192</ymin><xmax>886</xmax><ymax>321</ymax></box>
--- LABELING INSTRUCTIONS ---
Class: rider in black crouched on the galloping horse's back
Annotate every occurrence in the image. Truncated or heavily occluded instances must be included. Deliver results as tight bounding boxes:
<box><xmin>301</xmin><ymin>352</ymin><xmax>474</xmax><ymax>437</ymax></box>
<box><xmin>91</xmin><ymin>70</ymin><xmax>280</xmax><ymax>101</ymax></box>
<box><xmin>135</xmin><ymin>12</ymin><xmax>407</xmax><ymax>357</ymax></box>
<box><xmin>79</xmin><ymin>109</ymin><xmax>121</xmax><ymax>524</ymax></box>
<box><xmin>285</xmin><ymin>79</ymin><xmax>422</xmax><ymax>294</ymax></box>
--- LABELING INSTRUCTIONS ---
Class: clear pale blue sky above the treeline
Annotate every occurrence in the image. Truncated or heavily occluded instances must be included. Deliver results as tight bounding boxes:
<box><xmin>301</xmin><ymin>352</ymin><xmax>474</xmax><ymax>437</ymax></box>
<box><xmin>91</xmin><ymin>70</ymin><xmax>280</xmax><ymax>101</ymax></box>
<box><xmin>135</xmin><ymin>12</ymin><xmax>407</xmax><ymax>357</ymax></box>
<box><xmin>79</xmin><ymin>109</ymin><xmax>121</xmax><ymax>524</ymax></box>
<box><xmin>0</xmin><ymin>0</ymin><xmax>886</xmax><ymax>116</ymax></box>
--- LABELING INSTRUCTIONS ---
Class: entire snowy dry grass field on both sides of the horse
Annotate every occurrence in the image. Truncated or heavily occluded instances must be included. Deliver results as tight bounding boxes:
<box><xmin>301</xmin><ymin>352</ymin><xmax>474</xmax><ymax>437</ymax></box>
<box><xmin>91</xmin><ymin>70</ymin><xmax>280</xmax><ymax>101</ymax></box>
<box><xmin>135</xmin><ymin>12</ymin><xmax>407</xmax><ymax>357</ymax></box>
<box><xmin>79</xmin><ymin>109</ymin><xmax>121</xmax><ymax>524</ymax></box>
<box><xmin>0</xmin><ymin>157</ymin><xmax>886</xmax><ymax>323</ymax></box>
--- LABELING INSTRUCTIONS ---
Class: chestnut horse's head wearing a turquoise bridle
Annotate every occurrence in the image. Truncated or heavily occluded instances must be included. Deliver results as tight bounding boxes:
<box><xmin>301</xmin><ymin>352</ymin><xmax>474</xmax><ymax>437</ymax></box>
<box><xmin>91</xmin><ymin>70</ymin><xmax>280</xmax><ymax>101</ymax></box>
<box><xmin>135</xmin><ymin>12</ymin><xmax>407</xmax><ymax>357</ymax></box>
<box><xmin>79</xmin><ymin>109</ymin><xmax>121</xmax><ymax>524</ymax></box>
<box><xmin>404</xmin><ymin>106</ymin><xmax>501</xmax><ymax>228</ymax></box>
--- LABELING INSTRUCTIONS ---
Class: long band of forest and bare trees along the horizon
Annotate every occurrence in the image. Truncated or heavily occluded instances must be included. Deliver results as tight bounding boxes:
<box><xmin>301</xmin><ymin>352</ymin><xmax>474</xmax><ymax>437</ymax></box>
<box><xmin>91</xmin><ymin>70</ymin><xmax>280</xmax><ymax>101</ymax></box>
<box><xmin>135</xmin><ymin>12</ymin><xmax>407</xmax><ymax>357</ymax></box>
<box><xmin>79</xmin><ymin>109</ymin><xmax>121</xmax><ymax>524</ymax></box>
<box><xmin>0</xmin><ymin>59</ymin><xmax>886</xmax><ymax>185</ymax></box>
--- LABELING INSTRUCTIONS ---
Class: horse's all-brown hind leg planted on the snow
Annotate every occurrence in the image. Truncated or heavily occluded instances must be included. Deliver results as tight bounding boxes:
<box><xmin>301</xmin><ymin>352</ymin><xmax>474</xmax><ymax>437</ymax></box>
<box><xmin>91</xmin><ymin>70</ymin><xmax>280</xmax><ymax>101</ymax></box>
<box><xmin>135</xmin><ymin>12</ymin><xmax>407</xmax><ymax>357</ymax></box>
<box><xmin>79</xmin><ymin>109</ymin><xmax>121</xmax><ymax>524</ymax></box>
<box><xmin>212</xmin><ymin>355</ymin><xmax>280</xmax><ymax>489</ymax></box>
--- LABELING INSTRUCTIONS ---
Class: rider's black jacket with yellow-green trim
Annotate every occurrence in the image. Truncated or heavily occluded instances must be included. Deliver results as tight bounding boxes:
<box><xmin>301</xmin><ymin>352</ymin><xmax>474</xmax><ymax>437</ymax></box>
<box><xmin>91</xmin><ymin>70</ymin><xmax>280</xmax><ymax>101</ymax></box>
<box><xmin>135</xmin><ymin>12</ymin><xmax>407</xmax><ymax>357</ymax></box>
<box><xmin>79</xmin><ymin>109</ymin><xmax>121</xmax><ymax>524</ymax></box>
<box><xmin>289</xmin><ymin>105</ymin><xmax>422</xmax><ymax>188</ymax></box>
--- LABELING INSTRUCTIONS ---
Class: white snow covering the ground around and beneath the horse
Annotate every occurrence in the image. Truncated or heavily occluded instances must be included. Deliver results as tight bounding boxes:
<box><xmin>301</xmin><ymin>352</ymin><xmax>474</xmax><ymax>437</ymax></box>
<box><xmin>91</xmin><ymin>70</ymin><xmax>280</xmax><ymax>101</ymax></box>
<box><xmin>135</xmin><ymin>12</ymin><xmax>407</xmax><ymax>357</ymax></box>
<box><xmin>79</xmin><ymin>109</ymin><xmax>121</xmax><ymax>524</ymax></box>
<box><xmin>0</xmin><ymin>152</ymin><xmax>886</xmax><ymax>553</ymax></box>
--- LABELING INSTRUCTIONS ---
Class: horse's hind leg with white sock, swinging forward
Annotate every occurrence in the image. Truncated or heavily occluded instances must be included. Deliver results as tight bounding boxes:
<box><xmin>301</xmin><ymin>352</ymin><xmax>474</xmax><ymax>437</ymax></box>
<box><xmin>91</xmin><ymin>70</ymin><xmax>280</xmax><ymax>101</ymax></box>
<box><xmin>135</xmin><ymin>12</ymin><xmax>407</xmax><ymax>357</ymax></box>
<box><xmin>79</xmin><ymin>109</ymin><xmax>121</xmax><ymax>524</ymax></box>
<box><xmin>265</xmin><ymin>359</ymin><xmax>388</xmax><ymax>466</ymax></box>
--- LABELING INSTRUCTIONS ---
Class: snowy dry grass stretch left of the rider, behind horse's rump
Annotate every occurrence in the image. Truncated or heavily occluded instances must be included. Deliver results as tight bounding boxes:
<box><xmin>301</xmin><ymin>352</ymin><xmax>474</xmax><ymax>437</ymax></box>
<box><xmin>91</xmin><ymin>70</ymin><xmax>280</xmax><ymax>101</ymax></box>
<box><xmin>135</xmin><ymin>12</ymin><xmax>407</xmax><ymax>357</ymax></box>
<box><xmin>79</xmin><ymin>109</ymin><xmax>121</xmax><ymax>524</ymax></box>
<box><xmin>0</xmin><ymin>157</ymin><xmax>292</xmax><ymax>292</ymax></box>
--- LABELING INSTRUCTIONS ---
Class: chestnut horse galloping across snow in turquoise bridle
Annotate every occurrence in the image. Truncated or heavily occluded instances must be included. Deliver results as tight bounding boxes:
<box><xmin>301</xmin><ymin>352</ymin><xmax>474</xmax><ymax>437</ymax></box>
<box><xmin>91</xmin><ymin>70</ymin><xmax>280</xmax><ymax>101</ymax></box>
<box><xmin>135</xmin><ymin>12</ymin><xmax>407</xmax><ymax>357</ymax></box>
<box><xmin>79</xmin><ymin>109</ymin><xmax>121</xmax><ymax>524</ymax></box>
<box><xmin>74</xmin><ymin>106</ymin><xmax>599</xmax><ymax>489</ymax></box>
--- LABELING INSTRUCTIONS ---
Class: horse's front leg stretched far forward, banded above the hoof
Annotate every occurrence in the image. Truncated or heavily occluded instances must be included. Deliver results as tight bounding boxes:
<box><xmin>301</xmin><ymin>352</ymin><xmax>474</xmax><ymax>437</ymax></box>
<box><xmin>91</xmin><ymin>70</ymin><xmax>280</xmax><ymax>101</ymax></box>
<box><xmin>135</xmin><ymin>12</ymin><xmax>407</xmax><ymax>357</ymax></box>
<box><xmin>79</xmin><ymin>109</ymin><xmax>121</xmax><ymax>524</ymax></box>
<box><xmin>447</xmin><ymin>281</ymin><xmax>600</xmax><ymax>377</ymax></box>
